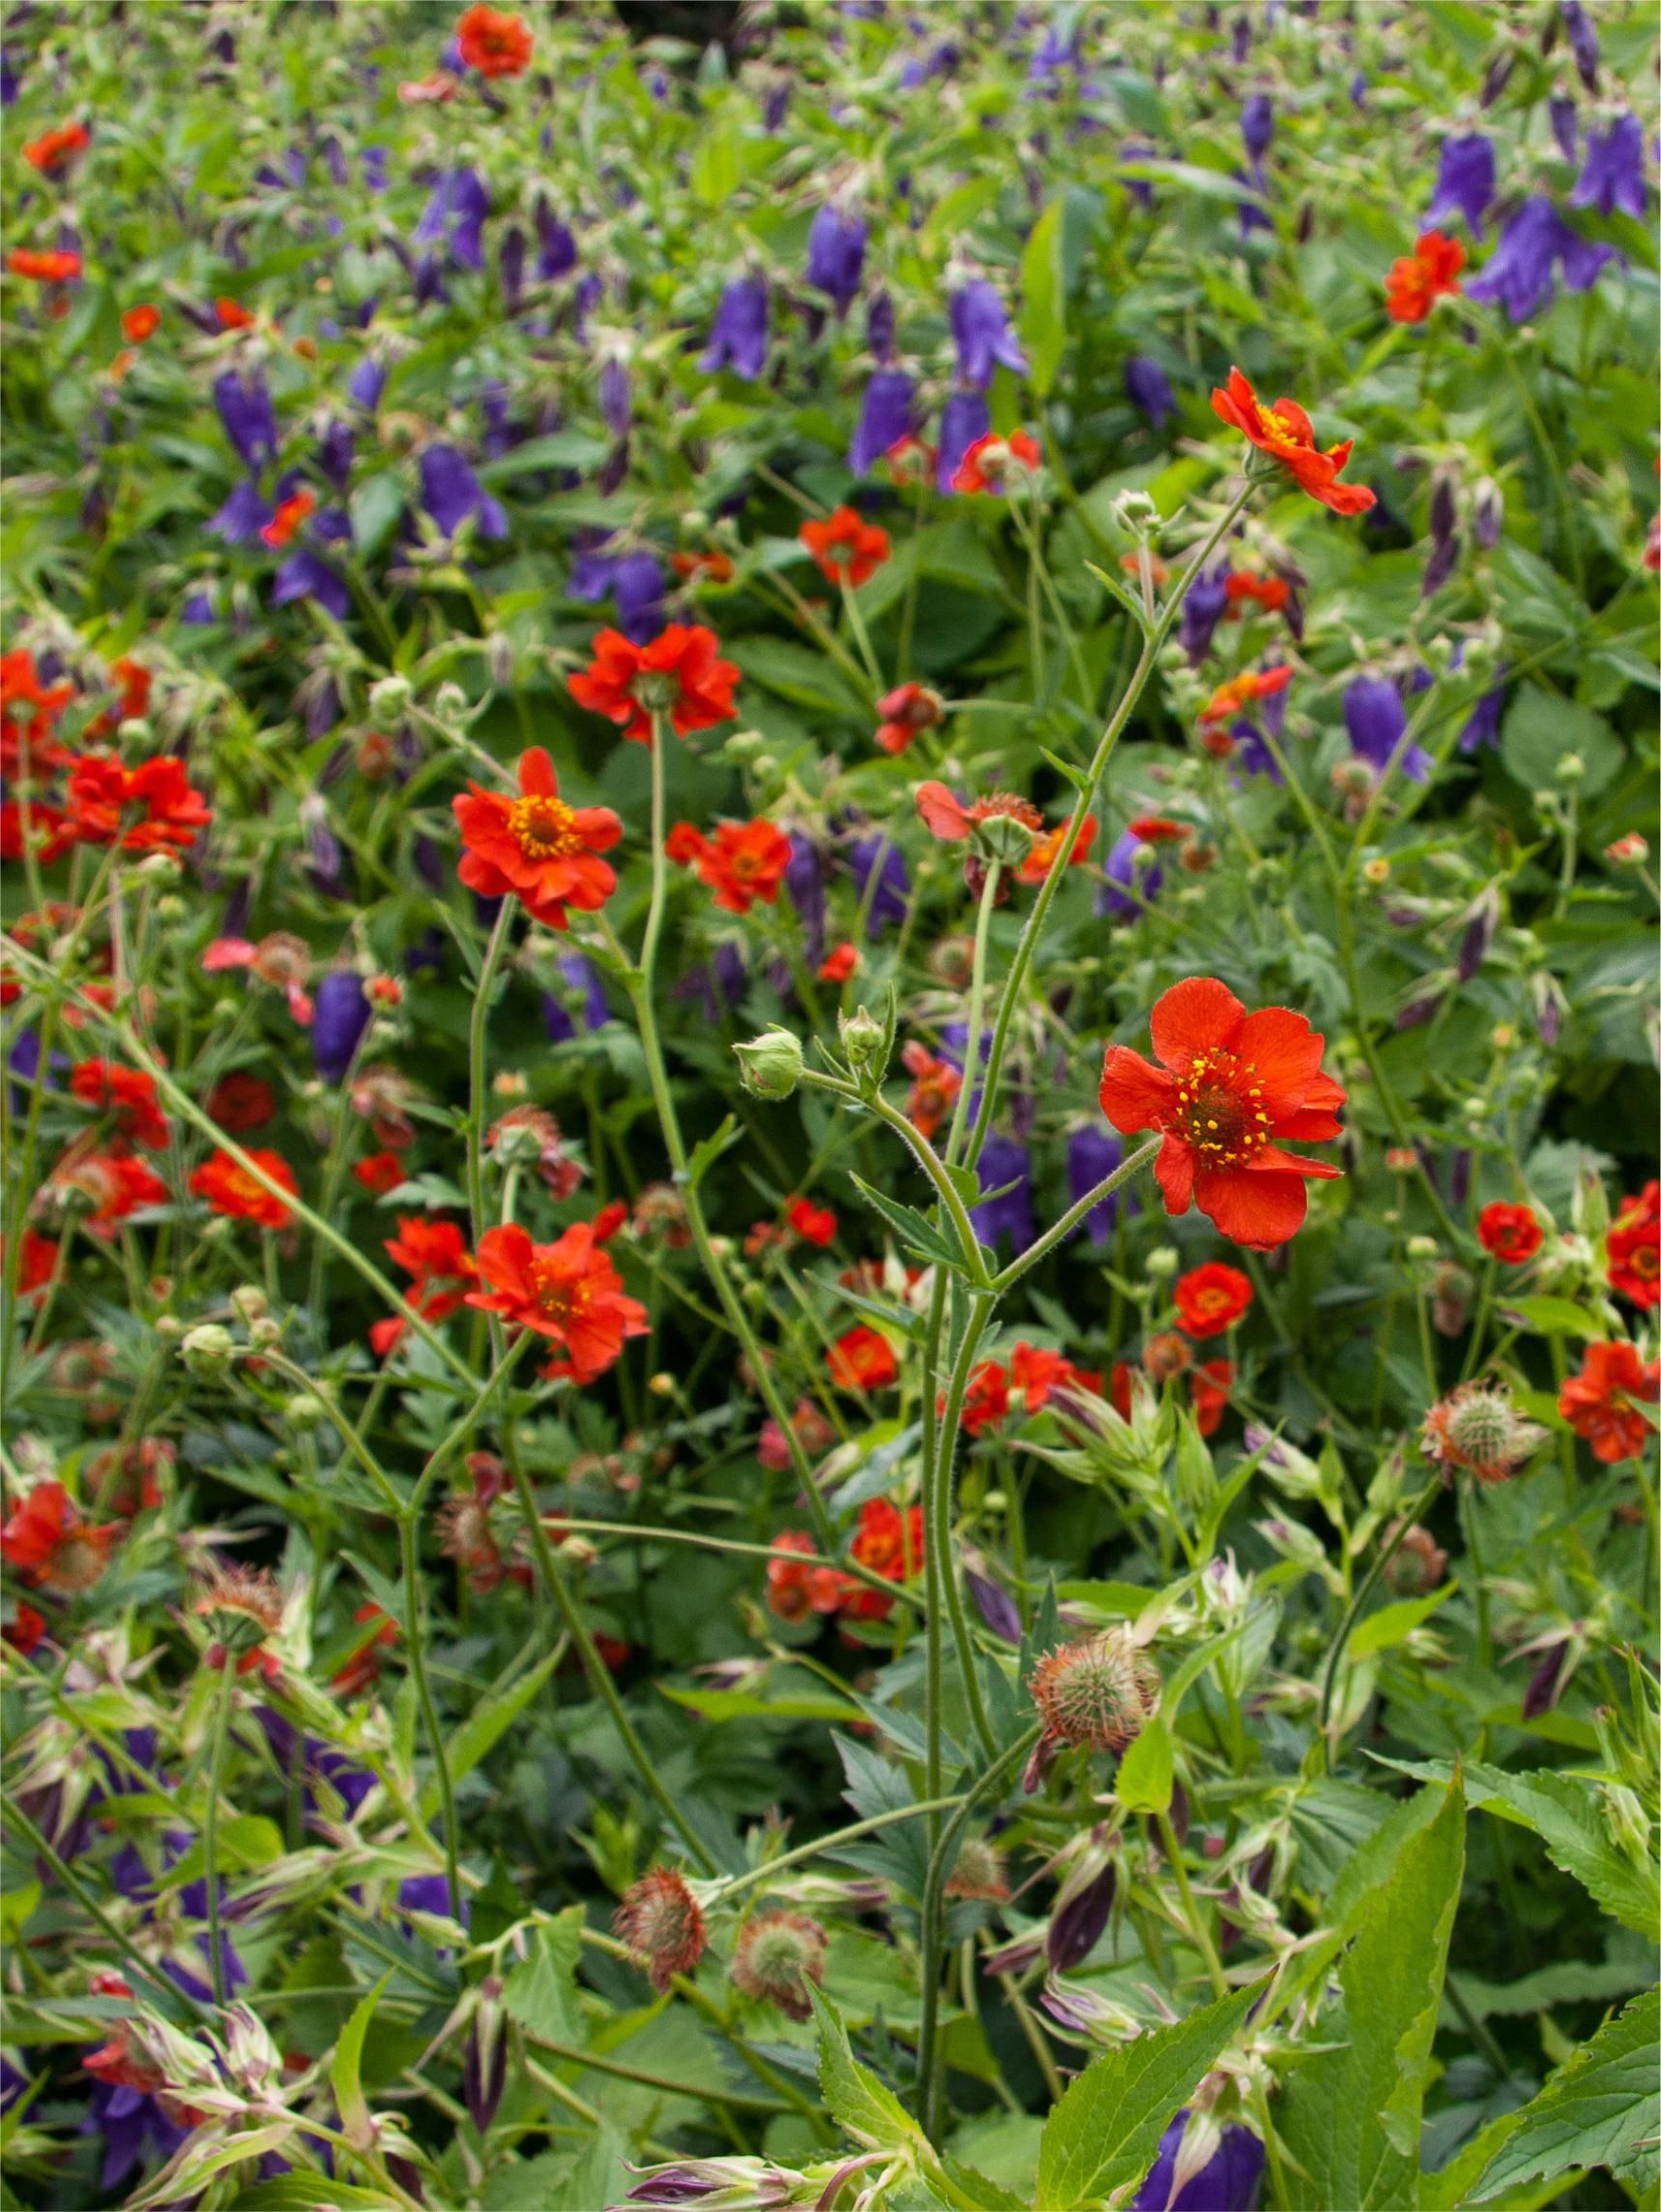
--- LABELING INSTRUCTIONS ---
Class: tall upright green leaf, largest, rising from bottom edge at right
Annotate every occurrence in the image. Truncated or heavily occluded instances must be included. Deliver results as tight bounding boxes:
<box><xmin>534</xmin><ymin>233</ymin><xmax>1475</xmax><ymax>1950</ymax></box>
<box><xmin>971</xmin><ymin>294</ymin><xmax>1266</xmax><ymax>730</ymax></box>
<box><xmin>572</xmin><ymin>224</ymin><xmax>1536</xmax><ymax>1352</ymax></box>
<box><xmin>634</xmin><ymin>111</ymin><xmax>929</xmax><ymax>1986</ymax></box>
<box><xmin>1281</xmin><ymin>1783</ymin><xmax>1464</xmax><ymax>2212</ymax></box>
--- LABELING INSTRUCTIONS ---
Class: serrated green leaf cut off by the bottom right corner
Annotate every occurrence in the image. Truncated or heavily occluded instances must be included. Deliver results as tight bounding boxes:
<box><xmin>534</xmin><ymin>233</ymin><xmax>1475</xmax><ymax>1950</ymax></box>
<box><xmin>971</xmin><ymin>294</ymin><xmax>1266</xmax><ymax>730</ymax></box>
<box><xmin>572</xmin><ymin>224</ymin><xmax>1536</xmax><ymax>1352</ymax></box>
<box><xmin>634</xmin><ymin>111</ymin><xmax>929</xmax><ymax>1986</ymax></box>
<box><xmin>1464</xmin><ymin>1989</ymin><xmax>1661</xmax><ymax>2203</ymax></box>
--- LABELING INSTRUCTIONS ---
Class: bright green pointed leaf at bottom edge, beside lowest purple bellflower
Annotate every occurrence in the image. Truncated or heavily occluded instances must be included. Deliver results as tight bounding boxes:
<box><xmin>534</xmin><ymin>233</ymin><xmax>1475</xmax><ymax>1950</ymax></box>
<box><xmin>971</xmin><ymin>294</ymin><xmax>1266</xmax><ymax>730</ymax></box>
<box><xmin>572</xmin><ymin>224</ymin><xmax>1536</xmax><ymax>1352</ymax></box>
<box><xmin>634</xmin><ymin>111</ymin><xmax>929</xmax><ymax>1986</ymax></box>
<box><xmin>1037</xmin><ymin>1982</ymin><xmax>1256</xmax><ymax>2212</ymax></box>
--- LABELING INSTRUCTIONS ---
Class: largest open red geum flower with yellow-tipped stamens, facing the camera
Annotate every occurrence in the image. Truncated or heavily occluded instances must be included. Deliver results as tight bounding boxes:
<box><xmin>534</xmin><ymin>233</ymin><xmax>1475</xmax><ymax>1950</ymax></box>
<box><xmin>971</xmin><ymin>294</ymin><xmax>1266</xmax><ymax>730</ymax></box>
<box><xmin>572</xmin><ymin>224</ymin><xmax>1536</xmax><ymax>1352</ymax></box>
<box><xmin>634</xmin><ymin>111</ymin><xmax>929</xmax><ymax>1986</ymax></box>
<box><xmin>1101</xmin><ymin>975</ymin><xmax>1345</xmax><ymax>1250</ymax></box>
